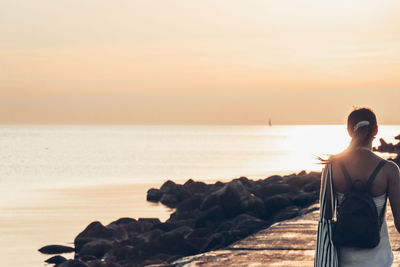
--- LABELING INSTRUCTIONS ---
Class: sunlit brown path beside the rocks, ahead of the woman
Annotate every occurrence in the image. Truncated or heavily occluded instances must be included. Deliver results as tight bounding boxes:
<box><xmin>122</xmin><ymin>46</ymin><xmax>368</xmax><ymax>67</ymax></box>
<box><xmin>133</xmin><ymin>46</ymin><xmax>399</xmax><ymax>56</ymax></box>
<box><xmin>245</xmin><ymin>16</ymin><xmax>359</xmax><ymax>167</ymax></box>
<box><xmin>175</xmin><ymin>206</ymin><xmax>400</xmax><ymax>267</ymax></box>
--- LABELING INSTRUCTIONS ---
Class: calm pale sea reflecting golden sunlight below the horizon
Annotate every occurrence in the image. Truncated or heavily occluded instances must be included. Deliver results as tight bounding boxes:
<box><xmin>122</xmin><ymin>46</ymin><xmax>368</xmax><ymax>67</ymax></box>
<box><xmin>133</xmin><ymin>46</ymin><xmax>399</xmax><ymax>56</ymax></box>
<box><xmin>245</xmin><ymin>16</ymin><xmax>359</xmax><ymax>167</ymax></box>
<box><xmin>0</xmin><ymin>125</ymin><xmax>400</xmax><ymax>267</ymax></box>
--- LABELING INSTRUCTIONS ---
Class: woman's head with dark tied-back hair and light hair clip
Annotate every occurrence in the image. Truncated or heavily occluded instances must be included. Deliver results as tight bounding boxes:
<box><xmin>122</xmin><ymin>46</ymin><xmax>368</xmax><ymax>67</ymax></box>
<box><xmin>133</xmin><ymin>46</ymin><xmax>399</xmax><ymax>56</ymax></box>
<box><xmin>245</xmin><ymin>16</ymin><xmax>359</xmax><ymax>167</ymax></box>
<box><xmin>347</xmin><ymin>108</ymin><xmax>378</xmax><ymax>148</ymax></box>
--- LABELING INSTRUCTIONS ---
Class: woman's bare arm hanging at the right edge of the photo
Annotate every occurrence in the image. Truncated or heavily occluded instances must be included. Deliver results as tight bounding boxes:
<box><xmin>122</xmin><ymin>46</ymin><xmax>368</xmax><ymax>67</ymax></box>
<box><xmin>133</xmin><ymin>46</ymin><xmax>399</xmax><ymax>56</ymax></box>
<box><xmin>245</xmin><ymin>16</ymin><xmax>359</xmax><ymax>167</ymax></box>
<box><xmin>387</xmin><ymin>161</ymin><xmax>400</xmax><ymax>233</ymax></box>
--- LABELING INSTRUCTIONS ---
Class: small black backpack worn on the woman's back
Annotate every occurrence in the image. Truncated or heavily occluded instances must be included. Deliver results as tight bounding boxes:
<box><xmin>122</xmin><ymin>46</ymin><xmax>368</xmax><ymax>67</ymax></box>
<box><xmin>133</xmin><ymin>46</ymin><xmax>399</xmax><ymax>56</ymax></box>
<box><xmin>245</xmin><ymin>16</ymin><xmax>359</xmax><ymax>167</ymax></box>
<box><xmin>333</xmin><ymin>160</ymin><xmax>387</xmax><ymax>248</ymax></box>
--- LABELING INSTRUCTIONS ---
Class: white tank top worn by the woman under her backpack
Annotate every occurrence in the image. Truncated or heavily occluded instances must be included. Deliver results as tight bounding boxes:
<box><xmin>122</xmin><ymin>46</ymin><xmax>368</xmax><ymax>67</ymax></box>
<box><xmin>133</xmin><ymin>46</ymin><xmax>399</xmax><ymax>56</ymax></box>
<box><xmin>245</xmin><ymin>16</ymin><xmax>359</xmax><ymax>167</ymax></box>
<box><xmin>336</xmin><ymin>192</ymin><xmax>393</xmax><ymax>267</ymax></box>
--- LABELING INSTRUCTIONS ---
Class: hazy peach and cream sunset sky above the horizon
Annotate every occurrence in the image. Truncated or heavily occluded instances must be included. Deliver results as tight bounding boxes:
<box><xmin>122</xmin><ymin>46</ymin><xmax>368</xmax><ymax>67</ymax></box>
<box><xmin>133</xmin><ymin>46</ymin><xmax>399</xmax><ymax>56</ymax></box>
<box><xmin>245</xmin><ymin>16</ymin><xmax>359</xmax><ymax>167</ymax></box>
<box><xmin>0</xmin><ymin>0</ymin><xmax>400</xmax><ymax>124</ymax></box>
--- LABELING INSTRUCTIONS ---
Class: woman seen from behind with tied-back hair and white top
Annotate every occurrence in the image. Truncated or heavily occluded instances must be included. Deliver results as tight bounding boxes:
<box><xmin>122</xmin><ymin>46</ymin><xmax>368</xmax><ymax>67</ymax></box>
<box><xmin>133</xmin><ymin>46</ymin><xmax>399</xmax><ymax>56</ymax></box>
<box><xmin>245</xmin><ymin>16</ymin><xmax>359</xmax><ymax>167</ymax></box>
<box><xmin>321</xmin><ymin>108</ymin><xmax>400</xmax><ymax>267</ymax></box>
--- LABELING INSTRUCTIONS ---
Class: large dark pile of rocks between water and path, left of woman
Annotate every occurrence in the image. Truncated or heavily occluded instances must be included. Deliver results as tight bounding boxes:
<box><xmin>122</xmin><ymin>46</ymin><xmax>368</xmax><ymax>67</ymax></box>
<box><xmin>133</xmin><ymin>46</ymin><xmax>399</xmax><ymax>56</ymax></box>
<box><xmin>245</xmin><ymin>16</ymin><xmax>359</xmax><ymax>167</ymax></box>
<box><xmin>39</xmin><ymin>171</ymin><xmax>321</xmax><ymax>267</ymax></box>
